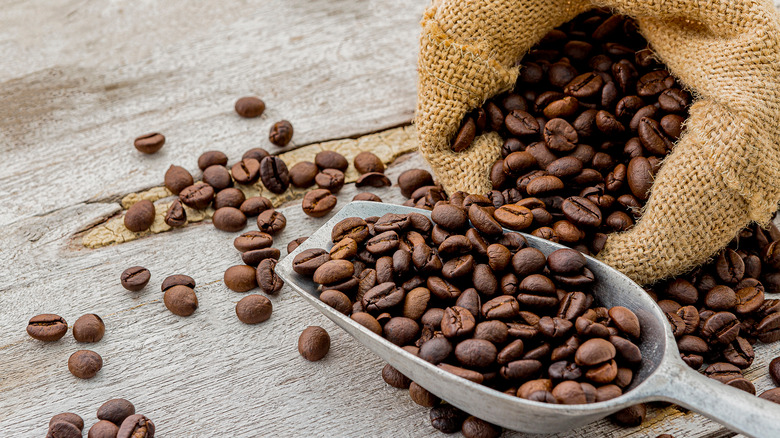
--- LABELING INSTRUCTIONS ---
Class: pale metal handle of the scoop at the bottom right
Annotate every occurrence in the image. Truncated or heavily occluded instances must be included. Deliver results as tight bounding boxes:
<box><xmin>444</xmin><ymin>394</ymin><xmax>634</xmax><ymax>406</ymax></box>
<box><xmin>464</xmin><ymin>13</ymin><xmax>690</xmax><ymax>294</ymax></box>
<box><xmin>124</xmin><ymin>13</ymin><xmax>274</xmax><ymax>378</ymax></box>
<box><xmin>653</xmin><ymin>360</ymin><xmax>780</xmax><ymax>438</ymax></box>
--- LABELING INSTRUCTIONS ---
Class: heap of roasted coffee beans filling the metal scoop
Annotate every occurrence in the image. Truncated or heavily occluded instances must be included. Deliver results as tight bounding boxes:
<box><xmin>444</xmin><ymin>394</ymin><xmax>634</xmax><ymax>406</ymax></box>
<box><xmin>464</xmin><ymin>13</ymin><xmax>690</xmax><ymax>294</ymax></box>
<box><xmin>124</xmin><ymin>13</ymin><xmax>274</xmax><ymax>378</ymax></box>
<box><xmin>293</xmin><ymin>211</ymin><xmax>642</xmax><ymax>406</ymax></box>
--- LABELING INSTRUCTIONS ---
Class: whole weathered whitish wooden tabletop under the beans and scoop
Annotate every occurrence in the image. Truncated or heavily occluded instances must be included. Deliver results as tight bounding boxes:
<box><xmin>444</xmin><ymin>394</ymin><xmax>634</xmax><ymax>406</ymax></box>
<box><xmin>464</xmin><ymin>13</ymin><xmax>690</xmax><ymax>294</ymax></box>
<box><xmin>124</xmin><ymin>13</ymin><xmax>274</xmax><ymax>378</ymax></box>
<box><xmin>0</xmin><ymin>0</ymin><xmax>778</xmax><ymax>437</ymax></box>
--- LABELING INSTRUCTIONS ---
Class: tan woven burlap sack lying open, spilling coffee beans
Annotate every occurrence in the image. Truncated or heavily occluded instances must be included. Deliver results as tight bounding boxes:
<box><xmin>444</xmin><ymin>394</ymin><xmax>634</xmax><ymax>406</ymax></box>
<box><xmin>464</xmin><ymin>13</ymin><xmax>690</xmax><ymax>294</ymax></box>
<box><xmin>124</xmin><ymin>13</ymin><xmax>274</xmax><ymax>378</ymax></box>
<box><xmin>416</xmin><ymin>0</ymin><xmax>780</xmax><ymax>283</ymax></box>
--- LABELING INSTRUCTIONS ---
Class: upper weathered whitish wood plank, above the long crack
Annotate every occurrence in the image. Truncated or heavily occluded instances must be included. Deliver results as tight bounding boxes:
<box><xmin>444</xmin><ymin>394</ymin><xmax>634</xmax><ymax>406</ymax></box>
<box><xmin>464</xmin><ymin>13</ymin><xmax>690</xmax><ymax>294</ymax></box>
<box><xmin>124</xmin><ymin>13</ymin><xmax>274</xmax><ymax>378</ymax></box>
<box><xmin>0</xmin><ymin>0</ymin><xmax>425</xmax><ymax>225</ymax></box>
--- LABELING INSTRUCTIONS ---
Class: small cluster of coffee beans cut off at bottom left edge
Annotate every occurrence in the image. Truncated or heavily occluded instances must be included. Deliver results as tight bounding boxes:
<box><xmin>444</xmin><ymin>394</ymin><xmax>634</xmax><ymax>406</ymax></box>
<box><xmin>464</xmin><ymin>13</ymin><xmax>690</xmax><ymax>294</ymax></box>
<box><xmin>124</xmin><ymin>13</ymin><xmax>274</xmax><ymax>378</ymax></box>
<box><xmin>46</xmin><ymin>398</ymin><xmax>155</xmax><ymax>438</ymax></box>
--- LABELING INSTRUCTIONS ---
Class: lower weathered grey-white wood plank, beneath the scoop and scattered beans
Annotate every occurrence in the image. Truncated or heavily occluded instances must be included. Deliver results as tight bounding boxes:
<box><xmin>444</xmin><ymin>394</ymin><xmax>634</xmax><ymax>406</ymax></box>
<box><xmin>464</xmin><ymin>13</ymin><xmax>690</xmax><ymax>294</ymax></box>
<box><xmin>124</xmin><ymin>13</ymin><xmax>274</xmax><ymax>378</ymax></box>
<box><xmin>0</xmin><ymin>154</ymin><xmax>780</xmax><ymax>437</ymax></box>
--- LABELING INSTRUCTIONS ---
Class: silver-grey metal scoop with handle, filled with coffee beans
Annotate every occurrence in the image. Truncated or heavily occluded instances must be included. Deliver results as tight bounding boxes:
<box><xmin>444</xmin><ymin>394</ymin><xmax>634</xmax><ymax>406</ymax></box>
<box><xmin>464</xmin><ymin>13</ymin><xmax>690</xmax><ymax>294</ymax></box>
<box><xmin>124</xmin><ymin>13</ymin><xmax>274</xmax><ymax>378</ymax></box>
<box><xmin>276</xmin><ymin>201</ymin><xmax>780</xmax><ymax>438</ymax></box>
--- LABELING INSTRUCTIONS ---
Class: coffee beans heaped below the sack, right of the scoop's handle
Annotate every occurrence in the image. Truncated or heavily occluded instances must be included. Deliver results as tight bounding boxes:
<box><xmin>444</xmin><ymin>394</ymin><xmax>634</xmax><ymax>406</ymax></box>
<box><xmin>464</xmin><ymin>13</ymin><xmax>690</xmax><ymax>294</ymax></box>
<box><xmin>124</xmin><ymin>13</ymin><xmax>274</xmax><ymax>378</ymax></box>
<box><xmin>648</xmin><ymin>225</ymin><xmax>780</xmax><ymax>394</ymax></box>
